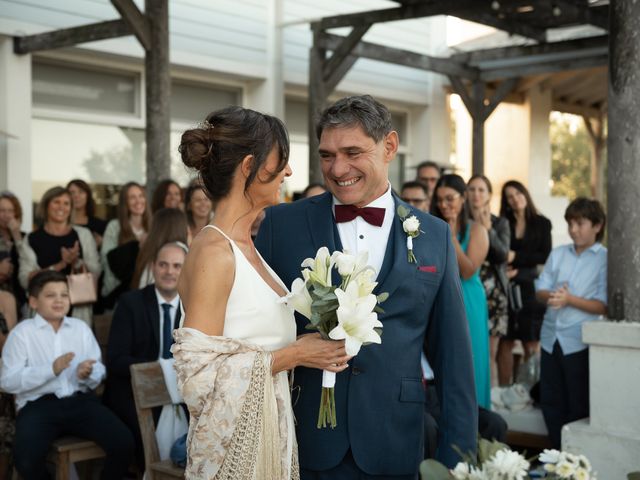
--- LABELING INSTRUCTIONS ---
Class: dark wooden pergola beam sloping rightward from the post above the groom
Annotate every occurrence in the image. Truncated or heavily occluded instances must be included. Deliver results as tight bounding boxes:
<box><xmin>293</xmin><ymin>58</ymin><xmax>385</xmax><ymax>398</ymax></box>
<box><xmin>318</xmin><ymin>33</ymin><xmax>479</xmax><ymax>79</ymax></box>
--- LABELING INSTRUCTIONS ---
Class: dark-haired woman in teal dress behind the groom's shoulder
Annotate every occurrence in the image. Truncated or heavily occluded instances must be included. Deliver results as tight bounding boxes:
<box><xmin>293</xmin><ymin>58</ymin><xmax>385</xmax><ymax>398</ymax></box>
<box><xmin>431</xmin><ymin>174</ymin><xmax>491</xmax><ymax>409</ymax></box>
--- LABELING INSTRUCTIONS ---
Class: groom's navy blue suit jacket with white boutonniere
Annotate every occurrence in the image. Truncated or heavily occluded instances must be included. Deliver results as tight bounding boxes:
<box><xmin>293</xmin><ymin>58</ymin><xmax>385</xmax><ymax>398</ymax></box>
<box><xmin>256</xmin><ymin>193</ymin><xmax>478</xmax><ymax>475</ymax></box>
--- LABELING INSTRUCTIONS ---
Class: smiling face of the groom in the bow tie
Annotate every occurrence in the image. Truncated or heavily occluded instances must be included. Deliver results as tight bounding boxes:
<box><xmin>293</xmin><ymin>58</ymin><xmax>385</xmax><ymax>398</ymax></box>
<box><xmin>319</xmin><ymin>126</ymin><xmax>398</xmax><ymax>207</ymax></box>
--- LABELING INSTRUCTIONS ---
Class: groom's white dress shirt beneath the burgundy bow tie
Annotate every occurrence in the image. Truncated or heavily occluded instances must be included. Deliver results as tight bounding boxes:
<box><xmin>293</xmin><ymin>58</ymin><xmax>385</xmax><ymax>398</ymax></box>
<box><xmin>333</xmin><ymin>185</ymin><xmax>396</xmax><ymax>277</ymax></box>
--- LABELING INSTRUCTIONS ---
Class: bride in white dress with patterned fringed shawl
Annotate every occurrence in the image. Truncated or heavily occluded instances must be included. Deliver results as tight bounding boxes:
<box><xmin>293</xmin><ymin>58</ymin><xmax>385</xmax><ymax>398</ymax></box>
<box><xmin>173</xmin><ymin>107</ymin><xmax>350</xmax><ymax>480</ymax></box>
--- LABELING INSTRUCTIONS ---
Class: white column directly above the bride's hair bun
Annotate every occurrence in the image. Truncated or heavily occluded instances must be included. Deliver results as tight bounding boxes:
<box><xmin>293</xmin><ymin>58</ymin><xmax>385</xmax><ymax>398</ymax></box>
<box><xmin>246</xmin><ymin>0</ymin><xmax>284</xmax><ymax>120</ymax></box>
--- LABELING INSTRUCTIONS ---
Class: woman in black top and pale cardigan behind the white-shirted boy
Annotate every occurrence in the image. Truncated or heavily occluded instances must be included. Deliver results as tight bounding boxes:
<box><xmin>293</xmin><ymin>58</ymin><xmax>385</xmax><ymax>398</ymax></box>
<box><xmin>18</xmin><ymin>187</ymin><xmax>102</xmax><ymax>325</ymax></box>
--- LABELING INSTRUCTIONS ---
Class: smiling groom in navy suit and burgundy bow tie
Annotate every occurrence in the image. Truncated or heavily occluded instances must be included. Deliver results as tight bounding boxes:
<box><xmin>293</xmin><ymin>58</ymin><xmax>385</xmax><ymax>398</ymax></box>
<box><xmin>256</xmin><ymin>95</ymin><xmax>478</xmax><ymax>480</ymax></box>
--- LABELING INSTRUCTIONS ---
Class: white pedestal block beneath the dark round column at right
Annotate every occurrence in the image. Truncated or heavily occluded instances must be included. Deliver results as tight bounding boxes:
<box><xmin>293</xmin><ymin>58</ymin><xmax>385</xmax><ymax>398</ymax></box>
<box><xmin>562</xmin><ymin>320</ymin><xmax>640</xmax><ymax>479</ymax></box>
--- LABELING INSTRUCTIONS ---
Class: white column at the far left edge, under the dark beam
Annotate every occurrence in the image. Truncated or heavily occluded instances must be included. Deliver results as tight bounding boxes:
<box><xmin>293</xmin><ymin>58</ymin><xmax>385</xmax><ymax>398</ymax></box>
<box><xmin>0</xmin><ymin>35</ymin><xmax>32</xmax><ymax>231</ymax></box>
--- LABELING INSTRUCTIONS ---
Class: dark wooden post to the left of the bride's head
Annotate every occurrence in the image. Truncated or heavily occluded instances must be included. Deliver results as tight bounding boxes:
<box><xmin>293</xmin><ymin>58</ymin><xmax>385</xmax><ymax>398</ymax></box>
<box><xmin>144</xmin><ymin>0</ymin><xmax>171</xmax><ymax>198</ymax></box>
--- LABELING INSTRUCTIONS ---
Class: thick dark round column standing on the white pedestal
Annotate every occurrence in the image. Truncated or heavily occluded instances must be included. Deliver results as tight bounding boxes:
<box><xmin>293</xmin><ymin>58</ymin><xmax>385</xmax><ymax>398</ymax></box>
<box><xmin>607</xmin><ymin>0</ymin><xmax>640</xmax><ymax>321</ymax></box>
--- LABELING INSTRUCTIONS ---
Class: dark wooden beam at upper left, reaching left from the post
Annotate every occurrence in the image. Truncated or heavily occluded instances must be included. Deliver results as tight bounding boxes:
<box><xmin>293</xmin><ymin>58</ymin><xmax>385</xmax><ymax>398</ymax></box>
<box><xmin>13</xmin><ymin>19</ymin><xmax>131</xmax><ymax>55</ymax></box>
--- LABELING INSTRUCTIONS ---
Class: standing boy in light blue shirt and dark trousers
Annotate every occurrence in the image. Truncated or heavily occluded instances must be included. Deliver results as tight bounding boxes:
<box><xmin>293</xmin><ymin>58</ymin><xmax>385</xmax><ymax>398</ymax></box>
<box><xmin>536</xmin><ymin>198</ymin><xmax>607</xmax><ymax>449</ymax></box>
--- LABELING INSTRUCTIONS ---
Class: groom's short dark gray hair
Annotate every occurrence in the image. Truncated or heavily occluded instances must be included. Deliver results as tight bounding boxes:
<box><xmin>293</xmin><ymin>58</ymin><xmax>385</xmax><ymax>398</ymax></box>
<box><xmin>316</xmin><ymin>95</ymin><xmax>392</xmax><ymax>143</ymax></box>
